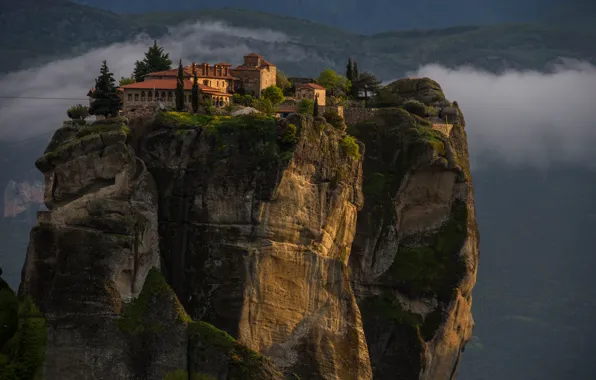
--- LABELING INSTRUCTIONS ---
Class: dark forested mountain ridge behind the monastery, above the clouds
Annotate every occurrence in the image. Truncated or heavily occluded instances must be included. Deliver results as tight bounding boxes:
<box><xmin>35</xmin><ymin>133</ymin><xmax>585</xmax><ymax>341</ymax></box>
<box><xmin>0</xmin><ymin>0</ymin><xmax>596</xmax><ymax>80</ymax></box>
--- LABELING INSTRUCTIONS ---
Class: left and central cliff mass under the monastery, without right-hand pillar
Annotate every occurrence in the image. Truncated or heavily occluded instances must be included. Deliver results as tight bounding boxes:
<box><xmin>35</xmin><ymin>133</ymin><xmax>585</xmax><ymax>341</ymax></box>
<box><xmin>20</xmin><ymin>114</ymin><xmax>371</xmax><ymax>380</ymax></box>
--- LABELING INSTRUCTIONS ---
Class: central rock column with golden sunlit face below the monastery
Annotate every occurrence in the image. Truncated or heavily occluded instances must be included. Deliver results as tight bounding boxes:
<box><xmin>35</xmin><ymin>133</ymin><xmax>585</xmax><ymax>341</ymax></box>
<box><xmin>139</xmin><ymin>115</ymin><xmax>371</xmax><ymax>380</ymax></box>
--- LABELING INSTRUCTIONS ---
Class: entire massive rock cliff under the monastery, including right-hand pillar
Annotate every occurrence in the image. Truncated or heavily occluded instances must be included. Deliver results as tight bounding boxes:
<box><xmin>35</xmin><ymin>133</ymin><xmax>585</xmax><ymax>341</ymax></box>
<box><xmin>0</xmin><ymin>75</ymin><xmax>478</xmax><ymax>380</ymax></box>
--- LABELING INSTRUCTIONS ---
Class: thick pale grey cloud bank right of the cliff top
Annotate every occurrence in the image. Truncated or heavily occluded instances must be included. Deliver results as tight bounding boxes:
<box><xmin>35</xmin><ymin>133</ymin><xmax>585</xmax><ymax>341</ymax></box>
<box><xmin>410</xmin><ymin>60</ymin><xmax>596</xmax><ymax>167</ymax></box>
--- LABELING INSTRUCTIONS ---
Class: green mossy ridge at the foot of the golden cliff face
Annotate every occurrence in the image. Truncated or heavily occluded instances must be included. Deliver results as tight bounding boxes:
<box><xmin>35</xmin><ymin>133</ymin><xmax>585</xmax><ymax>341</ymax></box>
<box><xmin>116</xmin><ymin>268</ymin><xmax>276</xmax><ymax>380</ymax></box>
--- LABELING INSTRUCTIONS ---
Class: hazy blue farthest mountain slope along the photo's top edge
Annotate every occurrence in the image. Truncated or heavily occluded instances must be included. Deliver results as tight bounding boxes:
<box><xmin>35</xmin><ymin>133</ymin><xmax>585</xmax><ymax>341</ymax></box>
<box><xmin>74</xmin><ymin>0</ymin><xmax>596</xmax><ymax>33</ymax></box>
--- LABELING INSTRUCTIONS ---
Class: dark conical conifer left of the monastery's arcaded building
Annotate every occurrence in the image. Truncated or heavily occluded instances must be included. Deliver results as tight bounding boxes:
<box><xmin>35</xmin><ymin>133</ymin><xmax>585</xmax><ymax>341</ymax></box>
<box><xmin>89</xmin><ymin>61</ymin><xmax>121</xmax><ymax>117</ymax></box>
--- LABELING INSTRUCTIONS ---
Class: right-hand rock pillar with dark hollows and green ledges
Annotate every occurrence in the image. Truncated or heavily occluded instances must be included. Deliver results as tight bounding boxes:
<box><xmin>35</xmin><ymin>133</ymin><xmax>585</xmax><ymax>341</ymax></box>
<box><xmin>349</xmin><ymin>78</ymin><xmax>478</xmax><ymax>380</ymax></box>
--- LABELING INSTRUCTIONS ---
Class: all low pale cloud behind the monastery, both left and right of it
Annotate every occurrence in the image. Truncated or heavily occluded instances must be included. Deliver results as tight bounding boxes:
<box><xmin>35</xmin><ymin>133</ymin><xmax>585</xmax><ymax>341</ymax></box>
<box><xmin>0</xmin><ymin>23</ymin><xmax>596</xmax><ymax>167</ymax></box>
